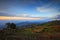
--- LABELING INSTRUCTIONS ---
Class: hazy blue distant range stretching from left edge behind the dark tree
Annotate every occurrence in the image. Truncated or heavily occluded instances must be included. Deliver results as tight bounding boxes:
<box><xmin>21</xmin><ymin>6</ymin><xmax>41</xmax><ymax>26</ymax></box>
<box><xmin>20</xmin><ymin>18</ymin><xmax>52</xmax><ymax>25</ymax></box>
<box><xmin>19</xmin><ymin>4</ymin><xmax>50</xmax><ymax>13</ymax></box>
<box><xmin>0</xmin><ymin>19</ymin><xmax>52</xmax><ymax>28</ymax></box>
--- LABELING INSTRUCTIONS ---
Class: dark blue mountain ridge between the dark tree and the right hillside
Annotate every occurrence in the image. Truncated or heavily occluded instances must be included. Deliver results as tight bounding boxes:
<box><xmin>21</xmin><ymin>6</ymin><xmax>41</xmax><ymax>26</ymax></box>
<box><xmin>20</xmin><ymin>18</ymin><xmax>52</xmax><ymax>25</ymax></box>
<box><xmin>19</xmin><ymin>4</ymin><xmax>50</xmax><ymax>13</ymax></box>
<box><xmin>16</xmin><ymin>19</ymin><xmax>52</xmax><ymax>26</ymax></box>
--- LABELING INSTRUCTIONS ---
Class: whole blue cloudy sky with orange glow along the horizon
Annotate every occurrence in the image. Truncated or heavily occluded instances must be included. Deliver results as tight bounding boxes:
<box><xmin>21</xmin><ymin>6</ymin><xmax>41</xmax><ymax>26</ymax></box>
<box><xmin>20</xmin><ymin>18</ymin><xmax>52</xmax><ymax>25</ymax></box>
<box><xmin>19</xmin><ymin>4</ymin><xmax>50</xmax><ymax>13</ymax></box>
<box><xmin>0</xmin><ymin>0</ymin><xmax>60</xmax><ymax>20</ymax></box>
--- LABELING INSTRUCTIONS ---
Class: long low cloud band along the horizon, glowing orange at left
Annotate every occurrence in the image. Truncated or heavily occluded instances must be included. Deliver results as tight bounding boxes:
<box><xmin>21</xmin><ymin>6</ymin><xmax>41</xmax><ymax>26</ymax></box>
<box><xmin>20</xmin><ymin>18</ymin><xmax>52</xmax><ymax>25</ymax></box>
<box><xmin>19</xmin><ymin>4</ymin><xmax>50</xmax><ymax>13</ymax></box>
<box><xmin>0</xmin><ymin>12</ymin><xmax>44</xmax><ymax>20</ymax></box>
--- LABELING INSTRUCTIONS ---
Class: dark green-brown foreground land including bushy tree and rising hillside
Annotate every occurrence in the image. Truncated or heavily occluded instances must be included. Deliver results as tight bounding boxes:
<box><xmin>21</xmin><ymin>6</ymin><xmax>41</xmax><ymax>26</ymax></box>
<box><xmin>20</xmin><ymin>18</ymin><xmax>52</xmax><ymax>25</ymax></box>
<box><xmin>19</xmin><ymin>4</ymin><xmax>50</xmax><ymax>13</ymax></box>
<box><xmin>0</xmin><ymin>20</ymin><xmax>60</xmax><ymax>40</ymax></box>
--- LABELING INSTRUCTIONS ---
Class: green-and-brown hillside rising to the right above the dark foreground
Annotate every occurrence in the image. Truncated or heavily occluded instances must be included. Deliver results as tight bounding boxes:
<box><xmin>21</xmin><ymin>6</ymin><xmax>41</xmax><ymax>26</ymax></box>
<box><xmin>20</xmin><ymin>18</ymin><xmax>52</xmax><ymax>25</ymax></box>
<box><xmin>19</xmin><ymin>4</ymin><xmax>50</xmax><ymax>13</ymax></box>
<box><xmin>22</xmin><ymin>20</ymin><xmax>60</xmax><ymax>32</ymax></box>
